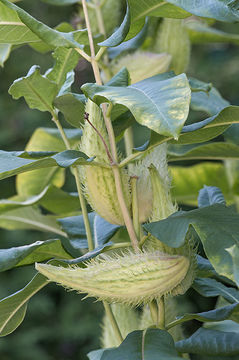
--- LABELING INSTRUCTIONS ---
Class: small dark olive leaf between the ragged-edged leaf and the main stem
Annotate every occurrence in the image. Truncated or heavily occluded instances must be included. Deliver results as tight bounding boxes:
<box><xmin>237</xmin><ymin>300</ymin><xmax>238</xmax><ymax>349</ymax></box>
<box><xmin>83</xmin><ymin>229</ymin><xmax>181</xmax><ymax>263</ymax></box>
<box><xmin>54</xmin><ymin>93</ymin><xmax>85</xmax><ymax>128</ymax></box>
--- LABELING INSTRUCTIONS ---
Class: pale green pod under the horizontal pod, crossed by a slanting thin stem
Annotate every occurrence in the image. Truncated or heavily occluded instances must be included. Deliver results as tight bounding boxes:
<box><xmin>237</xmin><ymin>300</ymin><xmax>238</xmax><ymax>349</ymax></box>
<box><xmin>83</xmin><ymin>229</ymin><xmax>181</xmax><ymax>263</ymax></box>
<box><xmin>101</xmin><ymin>304</ymin><xmax>140</xmax><ymax>348</ymax></box>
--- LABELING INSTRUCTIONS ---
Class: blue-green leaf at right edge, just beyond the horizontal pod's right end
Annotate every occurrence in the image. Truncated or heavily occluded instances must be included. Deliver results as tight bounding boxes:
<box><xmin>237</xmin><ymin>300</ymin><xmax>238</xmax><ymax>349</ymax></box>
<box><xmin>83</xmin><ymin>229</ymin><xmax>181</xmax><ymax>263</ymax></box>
<box><xmin>192</xmin><ymin>278</ymin><xmax>239</xmax><ymax>304</ymax></box>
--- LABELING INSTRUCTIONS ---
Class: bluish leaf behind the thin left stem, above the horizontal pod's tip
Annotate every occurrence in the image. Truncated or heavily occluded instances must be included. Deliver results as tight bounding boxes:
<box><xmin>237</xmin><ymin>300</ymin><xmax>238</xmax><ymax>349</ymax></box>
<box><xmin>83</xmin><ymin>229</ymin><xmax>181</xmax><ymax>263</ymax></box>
<box><xmin>58</xmin><ymin>212</ymin><xmax>119</xmax><ymax>249</ymax></box>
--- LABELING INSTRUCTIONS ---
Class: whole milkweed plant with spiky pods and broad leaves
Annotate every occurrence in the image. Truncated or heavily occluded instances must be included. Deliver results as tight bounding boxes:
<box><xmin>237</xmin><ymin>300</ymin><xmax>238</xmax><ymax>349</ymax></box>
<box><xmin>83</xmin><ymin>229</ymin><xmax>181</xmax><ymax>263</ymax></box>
<box><xmin>0</xmin><ymin>0</ymin><xmax>239</xmax><ymax>360</ymax></box>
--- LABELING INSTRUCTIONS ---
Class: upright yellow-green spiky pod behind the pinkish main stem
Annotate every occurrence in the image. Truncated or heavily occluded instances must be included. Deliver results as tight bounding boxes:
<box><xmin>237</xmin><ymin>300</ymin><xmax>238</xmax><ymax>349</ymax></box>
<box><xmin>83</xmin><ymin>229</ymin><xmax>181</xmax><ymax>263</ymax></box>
<box><xmin>79</xmin><ymin>100</ymin><xmax>131</xmax><ymax>225</ymax></box>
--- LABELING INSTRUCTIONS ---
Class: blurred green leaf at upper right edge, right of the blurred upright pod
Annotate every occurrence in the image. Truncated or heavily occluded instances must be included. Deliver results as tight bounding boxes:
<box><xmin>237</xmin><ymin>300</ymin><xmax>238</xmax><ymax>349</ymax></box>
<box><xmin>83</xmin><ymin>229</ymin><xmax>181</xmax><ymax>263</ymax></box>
<box><xmin>185</xmin><ymin>20</ymin><xmax>239</xmax><ymax>45</ymax></box>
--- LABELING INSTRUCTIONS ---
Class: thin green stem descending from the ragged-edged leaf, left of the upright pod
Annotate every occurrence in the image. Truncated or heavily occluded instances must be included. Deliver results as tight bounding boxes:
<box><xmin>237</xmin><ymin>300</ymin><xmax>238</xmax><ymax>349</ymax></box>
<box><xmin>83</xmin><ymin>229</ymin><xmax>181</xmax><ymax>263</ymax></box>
<box><xmin>52</xmin><ymin>113</ymin><xmax>94</xmax><ymax>251</ymax></box>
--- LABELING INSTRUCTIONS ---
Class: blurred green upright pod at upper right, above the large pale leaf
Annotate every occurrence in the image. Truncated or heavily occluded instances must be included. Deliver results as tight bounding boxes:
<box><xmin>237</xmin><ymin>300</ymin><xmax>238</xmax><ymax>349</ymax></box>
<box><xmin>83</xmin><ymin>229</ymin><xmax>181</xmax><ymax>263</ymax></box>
<box><xmin>154</xmin><ymin>18</ymin><xmax>191</xmax><ymax>74</ymax></box>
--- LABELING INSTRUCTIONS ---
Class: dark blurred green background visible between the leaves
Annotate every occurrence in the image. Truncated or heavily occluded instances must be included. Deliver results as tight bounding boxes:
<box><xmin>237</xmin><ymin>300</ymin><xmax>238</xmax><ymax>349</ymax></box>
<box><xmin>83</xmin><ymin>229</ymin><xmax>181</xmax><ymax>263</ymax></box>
<box><xmin>0</xmin><ymin>0</ymin><xmax>239</xmax><ymax>360</ymax></box>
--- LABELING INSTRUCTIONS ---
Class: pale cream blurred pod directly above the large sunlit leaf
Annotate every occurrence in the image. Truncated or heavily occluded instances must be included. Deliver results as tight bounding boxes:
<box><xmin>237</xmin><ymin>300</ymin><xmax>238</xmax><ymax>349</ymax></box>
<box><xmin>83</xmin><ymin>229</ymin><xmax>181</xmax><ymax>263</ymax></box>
<box><xmin>107</xmin><ymin>50</ymin><xmax>171</xmax><ymax>84</ymax></box>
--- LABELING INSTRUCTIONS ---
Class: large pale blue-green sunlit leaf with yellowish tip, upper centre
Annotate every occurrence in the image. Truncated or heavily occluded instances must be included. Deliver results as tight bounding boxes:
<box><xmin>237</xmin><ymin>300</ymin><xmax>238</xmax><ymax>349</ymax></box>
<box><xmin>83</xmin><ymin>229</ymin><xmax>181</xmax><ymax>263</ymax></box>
<box><xmin>82</xmin><ymin>73</ymin><xmax>190</xmax><ymax>138</ymax></box>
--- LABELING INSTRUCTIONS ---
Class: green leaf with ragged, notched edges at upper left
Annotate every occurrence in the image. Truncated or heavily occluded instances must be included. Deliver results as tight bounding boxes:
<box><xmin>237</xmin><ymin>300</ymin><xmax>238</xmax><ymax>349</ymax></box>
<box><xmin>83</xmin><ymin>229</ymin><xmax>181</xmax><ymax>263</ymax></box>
<box><xmin>9</xmin><ymin>65</ymin><xmax>58</xmax><ymax>113</ymax></box>
